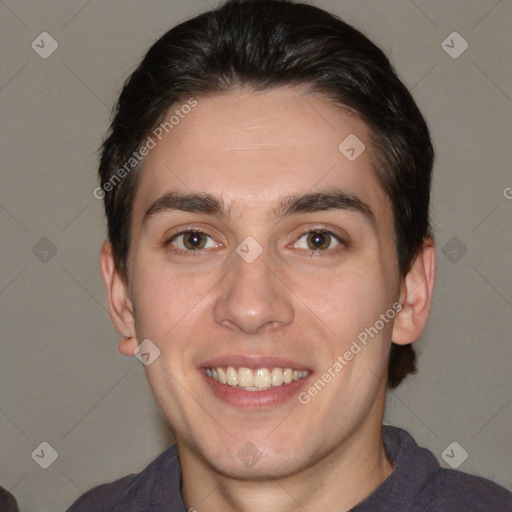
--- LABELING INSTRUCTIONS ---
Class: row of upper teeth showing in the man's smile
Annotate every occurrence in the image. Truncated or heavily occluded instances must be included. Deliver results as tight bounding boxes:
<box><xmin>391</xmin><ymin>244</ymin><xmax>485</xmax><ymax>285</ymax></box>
<box><xmin>206</xmin><ymin>366</ymin><xmax>309</xmax><ymax>391</ymax></box>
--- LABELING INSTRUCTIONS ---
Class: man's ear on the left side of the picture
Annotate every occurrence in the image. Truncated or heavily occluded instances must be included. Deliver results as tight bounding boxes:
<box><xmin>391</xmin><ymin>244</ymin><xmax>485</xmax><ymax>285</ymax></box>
<box><xmin>101</xmin><ymin>240</ymin><xmax>137</xmax><ymax>356</ymax></box>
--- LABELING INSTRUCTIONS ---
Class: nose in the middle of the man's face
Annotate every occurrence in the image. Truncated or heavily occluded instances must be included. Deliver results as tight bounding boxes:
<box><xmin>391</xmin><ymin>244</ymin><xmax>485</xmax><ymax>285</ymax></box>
<box><xmin>214</xmin><ymin>249</ymin><xmax>294</xmax><ymax>334</ymax></box>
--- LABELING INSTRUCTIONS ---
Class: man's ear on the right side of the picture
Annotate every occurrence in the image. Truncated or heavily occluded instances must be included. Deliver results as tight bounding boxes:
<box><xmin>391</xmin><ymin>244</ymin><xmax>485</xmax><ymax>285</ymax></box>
<box><xmin>391</xmin><ymin>238</ymin><xmax>436</xmax><ymax>345</ymax></box>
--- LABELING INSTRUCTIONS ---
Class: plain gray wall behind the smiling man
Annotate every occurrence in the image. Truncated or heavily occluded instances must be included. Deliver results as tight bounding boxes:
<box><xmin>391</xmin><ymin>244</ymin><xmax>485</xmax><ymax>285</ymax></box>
<box><xmin>0</xmin><ymin>0</ymin><xmax>512</xmax><ymax>512</ymax></box>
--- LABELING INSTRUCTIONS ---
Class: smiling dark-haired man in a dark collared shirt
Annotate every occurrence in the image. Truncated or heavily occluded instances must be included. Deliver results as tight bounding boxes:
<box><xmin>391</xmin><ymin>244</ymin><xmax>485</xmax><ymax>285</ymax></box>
<box><xmin>70</xmin><ymin>0</ymin><xmax>512</xmax><ymax>512</ymax></box>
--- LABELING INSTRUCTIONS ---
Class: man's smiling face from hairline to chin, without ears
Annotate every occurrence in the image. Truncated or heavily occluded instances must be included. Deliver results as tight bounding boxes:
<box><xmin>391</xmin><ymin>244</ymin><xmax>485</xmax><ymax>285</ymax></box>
<box><xmin>117</xmin><ymin>88</ymin><xmax>400</xmax><ymax>478</ymax></box>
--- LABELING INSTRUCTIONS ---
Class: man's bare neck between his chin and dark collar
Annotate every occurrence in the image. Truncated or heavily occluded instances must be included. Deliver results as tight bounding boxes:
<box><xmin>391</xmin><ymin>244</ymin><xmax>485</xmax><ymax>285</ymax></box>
<box><xmin>178</xmin><ymin>400</ymin><xmax>393</xmax><ymax>512</ymax></box>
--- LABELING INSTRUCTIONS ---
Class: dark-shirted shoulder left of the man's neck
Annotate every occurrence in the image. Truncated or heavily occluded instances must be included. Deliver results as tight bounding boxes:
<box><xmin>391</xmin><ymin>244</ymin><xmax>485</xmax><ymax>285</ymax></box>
<box><xmin>67</xmin><ymin>446</ymin><xmax>181</xmax><ymax>512</ymax></box>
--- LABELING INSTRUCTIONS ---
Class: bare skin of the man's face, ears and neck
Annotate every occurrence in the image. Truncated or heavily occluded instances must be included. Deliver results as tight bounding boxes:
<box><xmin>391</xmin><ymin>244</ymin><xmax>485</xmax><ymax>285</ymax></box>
<box><xmin>102</xmin><ymin>87</ymin><xmax>435</xmax><ymax>512</ymax></box>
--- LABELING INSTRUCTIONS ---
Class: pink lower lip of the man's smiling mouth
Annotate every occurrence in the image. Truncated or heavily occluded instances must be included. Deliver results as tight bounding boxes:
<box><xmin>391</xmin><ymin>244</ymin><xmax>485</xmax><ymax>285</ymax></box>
<box><xmin>199</xmin><ymin>369</ymin><xmax>312</xmax><ymax>409</ymax></box>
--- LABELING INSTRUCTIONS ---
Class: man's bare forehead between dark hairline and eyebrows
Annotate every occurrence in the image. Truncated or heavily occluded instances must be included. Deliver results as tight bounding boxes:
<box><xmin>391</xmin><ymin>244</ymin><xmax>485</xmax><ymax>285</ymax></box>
<box><xmin>134</xmin><ymin>87</ymin><xmax>390</xmax><ymax>224</ymax></box>
